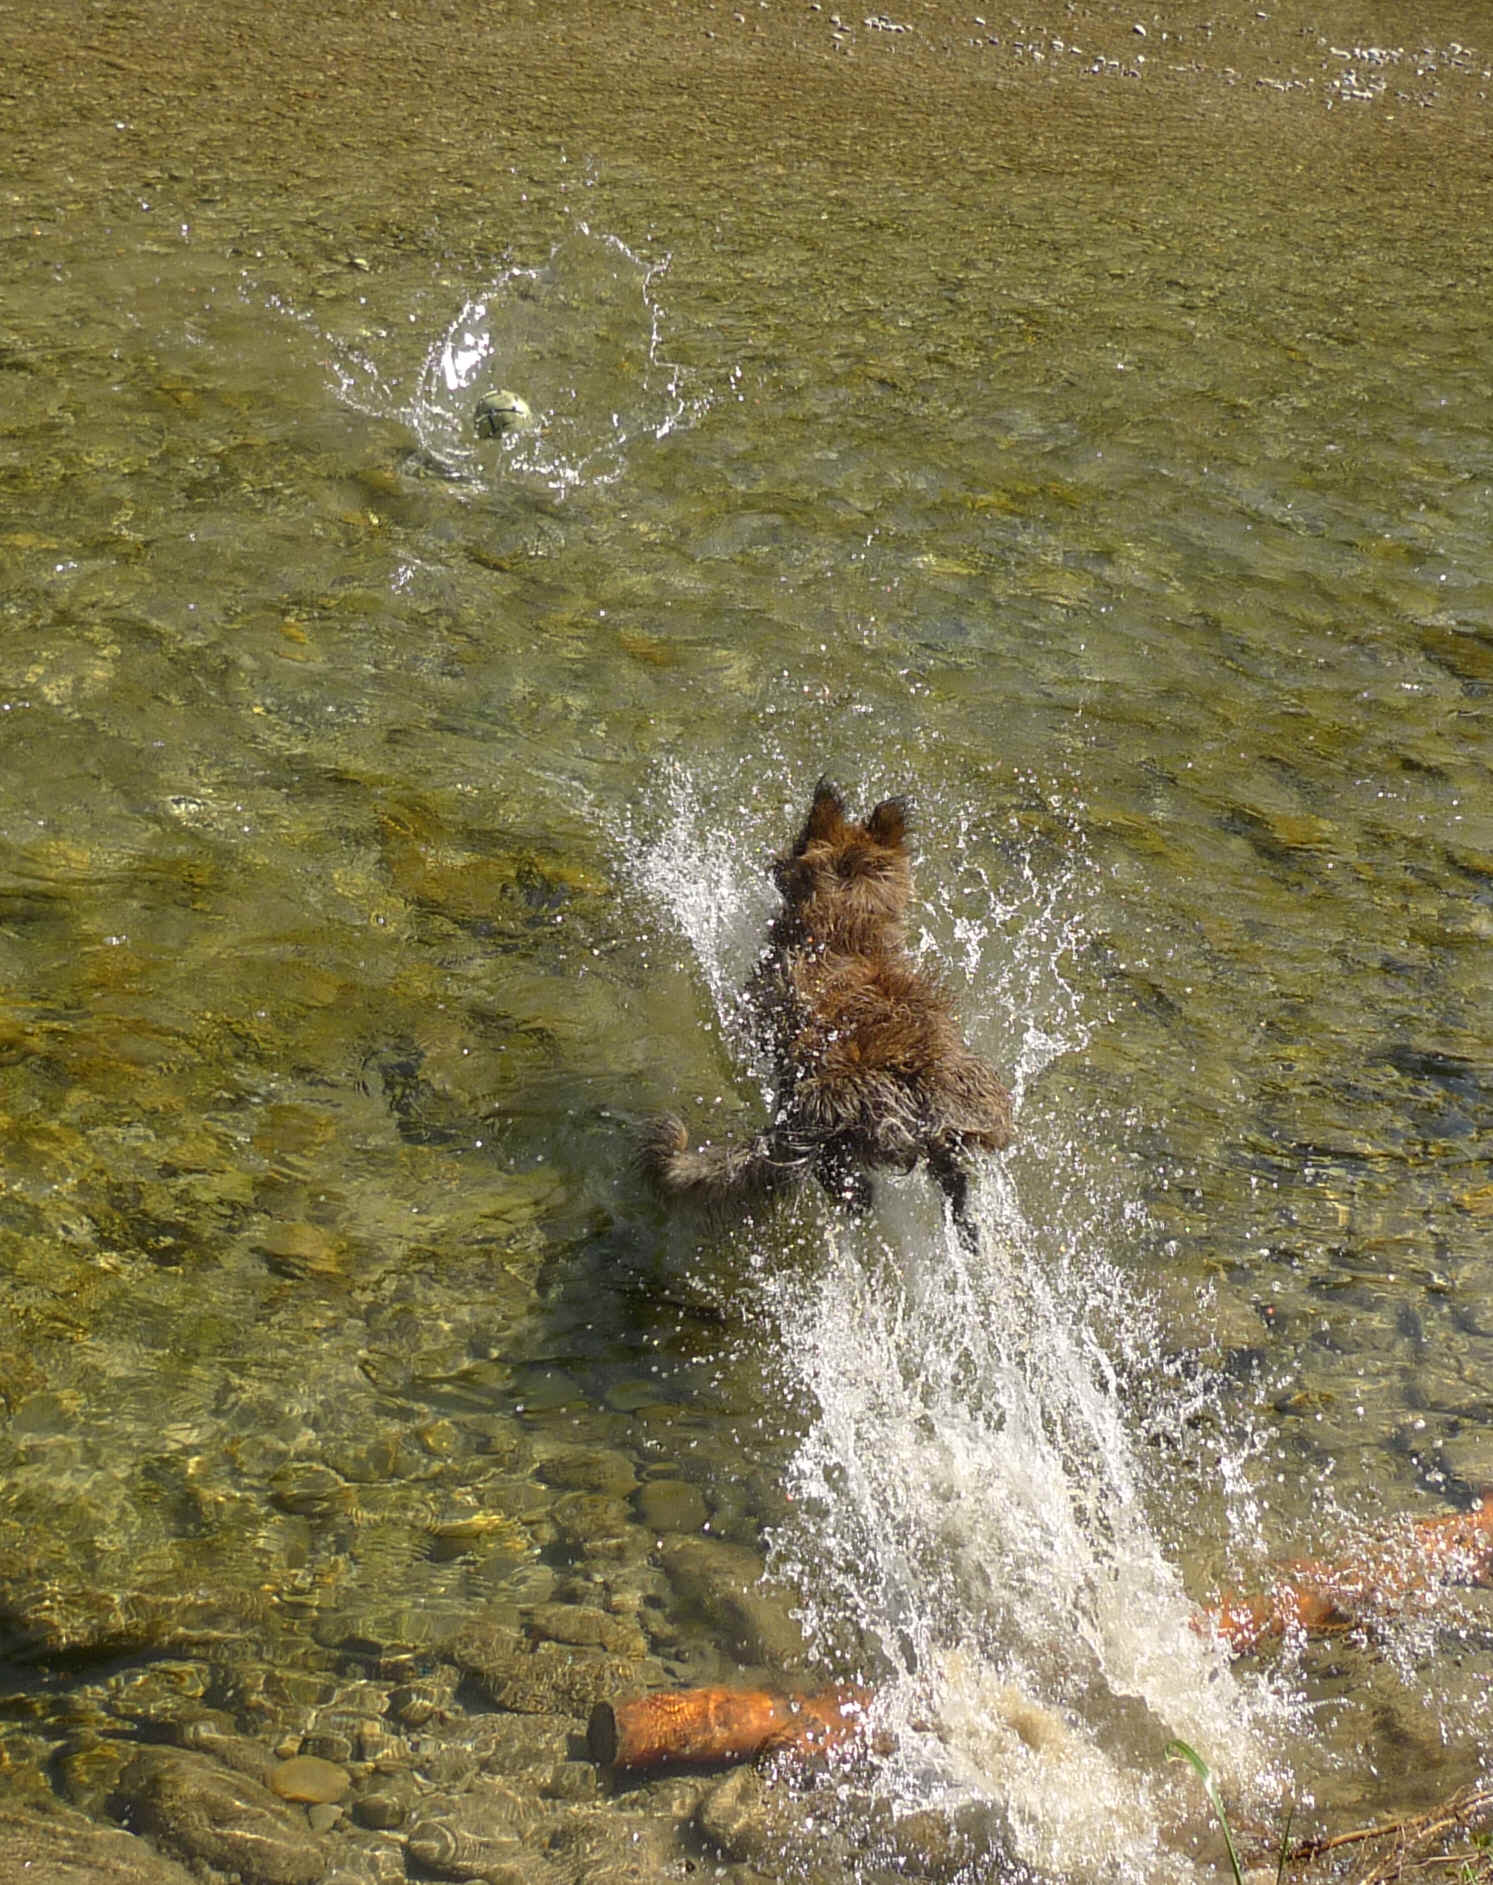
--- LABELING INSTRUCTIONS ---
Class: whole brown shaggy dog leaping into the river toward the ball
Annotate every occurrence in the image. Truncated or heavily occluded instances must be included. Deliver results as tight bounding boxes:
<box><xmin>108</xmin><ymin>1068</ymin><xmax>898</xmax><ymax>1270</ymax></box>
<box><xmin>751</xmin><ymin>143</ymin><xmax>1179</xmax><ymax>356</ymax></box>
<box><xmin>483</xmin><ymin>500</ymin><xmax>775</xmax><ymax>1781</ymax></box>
<box><xmin>643</xmin><ymin>779</ymin><xmax>1012</xmax><ymax>1244</ymax></box>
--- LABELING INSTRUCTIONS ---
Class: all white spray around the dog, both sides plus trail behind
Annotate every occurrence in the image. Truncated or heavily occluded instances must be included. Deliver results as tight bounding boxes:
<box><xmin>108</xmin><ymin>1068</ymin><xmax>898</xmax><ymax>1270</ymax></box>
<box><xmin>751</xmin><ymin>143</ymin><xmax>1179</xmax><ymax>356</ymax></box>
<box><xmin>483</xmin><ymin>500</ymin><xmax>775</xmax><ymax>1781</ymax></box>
<box><xmin>633</xmin><ymin>769</ymin><xmax>1284</xmax><ymax>1885</ymax></box>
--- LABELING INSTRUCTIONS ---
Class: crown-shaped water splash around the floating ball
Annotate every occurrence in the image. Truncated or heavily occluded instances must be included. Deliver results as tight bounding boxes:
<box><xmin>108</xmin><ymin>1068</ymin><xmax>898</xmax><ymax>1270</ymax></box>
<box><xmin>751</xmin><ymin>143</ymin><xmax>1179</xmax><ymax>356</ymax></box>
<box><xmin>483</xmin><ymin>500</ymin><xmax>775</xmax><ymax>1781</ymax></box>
<box><xmin>296</xmin><ymin>222</ymin><xmax>709</xmax><ymax>498</ymax></box>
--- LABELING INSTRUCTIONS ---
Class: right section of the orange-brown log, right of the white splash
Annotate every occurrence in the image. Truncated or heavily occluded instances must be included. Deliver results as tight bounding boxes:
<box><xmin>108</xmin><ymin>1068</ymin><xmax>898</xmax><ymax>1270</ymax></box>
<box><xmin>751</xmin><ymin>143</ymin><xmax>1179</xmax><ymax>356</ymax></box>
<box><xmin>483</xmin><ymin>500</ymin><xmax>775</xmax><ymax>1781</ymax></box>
<box><xmin>1197</xmin><ymin>1495</ymin><xmax>1493</xmax><ymax>1655</ymax></box>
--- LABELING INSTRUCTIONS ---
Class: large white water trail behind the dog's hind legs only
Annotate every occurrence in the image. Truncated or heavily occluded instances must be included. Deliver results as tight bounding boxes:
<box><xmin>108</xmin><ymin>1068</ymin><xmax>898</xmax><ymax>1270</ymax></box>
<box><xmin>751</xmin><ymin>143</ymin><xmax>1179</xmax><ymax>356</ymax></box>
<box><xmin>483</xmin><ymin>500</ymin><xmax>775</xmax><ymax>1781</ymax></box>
<box><xmin>767</xmin><ymin>1198</ymin><xmax>1265</xmax><ymax>1881</ymax></box>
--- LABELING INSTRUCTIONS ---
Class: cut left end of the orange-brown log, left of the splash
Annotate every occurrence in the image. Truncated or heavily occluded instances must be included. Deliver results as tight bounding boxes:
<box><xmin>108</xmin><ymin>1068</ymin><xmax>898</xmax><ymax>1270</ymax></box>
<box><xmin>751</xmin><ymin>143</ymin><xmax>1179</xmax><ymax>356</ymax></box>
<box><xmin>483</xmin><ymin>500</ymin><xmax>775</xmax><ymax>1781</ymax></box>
<box><xmin>586</xmin><ymin>1689</ymin><xmax>869</xmax><ymax>1768</ymax></box>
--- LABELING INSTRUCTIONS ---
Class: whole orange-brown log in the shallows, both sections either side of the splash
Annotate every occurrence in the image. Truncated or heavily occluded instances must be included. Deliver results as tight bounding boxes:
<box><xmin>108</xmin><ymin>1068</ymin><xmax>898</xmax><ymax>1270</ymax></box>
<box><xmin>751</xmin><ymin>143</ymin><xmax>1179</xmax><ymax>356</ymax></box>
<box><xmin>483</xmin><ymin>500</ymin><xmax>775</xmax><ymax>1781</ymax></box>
<box><xmin>586</xmin><ymin>1491</ymin><xmax>1493</xmax><ymax>1770</ymax></box>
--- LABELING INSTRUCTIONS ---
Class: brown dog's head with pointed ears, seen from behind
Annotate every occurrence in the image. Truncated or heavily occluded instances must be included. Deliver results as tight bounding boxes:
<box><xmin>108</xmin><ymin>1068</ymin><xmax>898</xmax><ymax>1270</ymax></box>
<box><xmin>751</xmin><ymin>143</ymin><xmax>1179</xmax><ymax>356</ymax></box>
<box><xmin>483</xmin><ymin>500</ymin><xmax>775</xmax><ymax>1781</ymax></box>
<box><xmin>773</xmin><ymin>779</ymin><xmax>912</xmax><ymax>950</ymax></box>
